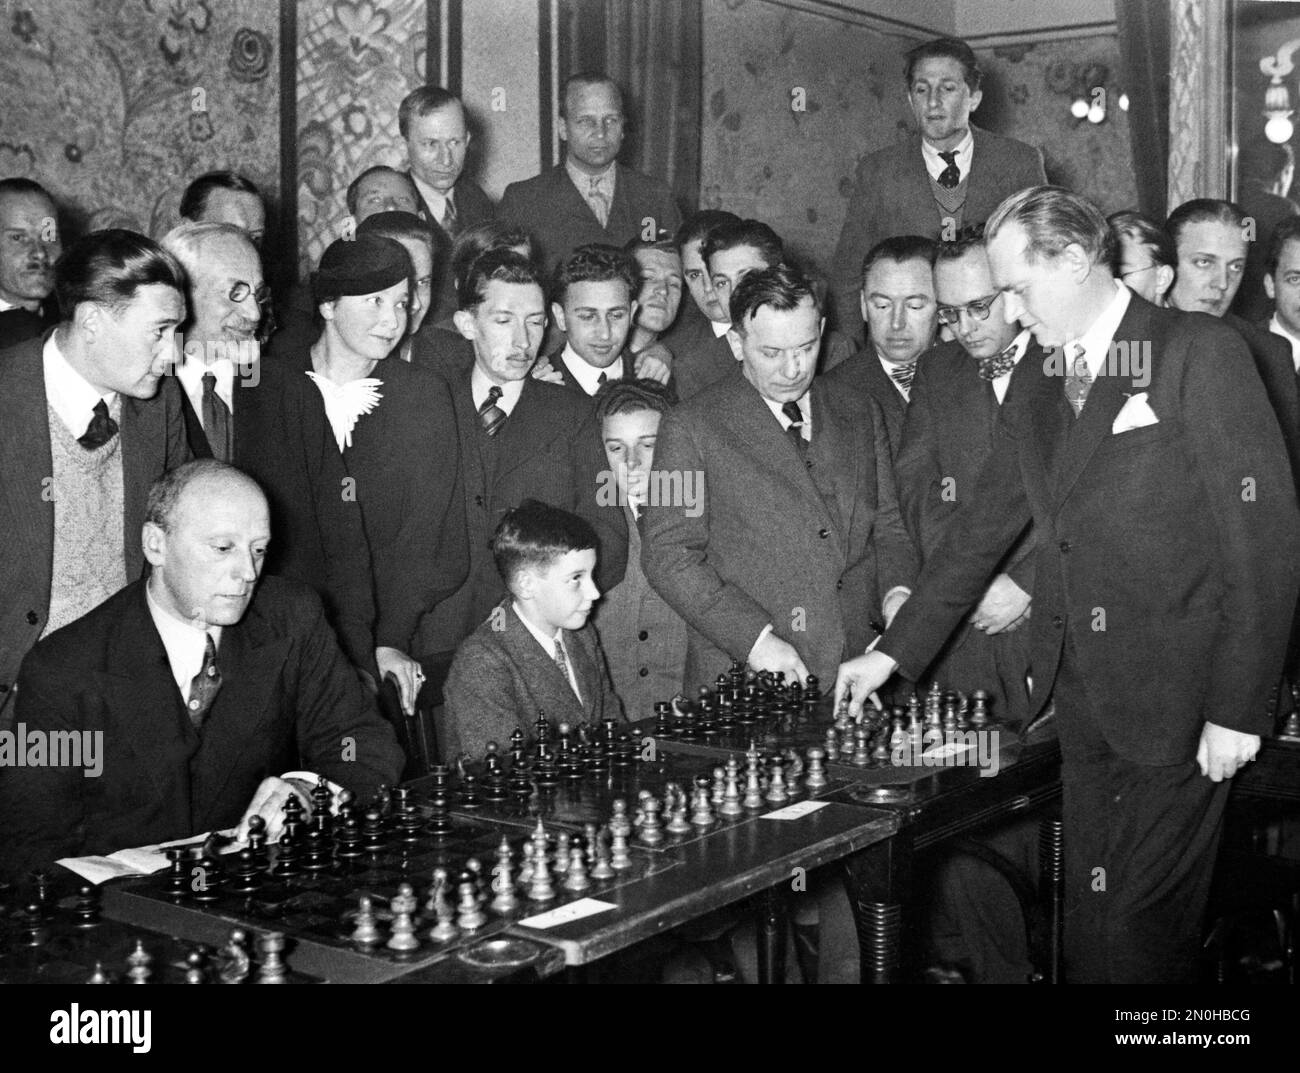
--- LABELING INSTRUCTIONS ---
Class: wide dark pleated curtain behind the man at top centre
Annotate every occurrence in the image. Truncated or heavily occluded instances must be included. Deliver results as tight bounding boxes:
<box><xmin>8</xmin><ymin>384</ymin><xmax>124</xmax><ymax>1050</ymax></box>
<box><xmin>555</xmin><ymin>0</ymin><xmax>703</xmax><ymax>211</ymax></box>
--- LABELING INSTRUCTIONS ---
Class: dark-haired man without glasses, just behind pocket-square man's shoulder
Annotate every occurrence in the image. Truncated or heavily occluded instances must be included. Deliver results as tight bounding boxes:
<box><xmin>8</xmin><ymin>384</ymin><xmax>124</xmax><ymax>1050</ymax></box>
<box><xmin>1165</xmin><ymin>198</ymin><xmax>1300</xmax><ymax>488</ymax></box>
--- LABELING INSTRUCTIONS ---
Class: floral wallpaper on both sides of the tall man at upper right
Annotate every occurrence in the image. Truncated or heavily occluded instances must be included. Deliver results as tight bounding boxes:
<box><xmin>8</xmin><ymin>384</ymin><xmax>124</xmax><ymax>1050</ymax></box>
<box><xmin>701</xmin><ymin>0</ymin><xmax>1136</xmax><ymax>280</ymax></box>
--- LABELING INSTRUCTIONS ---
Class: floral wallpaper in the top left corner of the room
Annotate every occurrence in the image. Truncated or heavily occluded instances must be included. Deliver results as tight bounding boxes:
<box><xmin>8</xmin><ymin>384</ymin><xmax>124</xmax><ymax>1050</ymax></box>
<box><xmin>0</xmin><ymin>0</ymin><xmax>280</xmax><ymax>235</ymax></box>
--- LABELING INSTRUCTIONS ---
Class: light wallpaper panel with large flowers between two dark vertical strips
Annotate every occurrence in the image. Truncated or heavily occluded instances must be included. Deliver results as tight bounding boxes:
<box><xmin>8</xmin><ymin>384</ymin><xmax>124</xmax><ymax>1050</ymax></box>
<box><xmin>298</xmin><ymin>0</ymin><xmax>428</xmax><ymax>277</ymax></box>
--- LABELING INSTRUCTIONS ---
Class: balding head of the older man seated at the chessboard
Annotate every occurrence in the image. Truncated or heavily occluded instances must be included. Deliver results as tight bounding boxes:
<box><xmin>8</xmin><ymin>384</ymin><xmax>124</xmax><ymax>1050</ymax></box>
<box><xmin>143</xmin><ymin>459</ymin><xmax>270</xmax><ymax>629</ymax></box>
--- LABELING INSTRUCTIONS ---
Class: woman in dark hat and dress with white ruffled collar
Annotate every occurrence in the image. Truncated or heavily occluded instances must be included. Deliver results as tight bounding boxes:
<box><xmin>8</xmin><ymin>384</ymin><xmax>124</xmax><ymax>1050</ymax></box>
<box><xmin>297</xmin><ymin>234</ymin><xmax>469</xmax><ymax>713</ymax></box>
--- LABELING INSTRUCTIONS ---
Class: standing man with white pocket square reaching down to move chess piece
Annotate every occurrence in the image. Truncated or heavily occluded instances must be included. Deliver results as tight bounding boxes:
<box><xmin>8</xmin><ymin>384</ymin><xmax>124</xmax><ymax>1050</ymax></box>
<box><xmin>836</xmin><ymin>187</ymin><xmax>1300</xmax><ymax>983</ymax></box>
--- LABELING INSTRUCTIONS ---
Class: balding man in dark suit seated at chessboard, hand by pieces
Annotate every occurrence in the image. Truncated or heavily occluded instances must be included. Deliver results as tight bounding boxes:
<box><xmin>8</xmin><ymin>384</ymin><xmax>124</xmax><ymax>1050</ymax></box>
<box><xmin>0</xmin><ymin>459</ymin><xmax>404</xmax><ymax>879</ymax></box>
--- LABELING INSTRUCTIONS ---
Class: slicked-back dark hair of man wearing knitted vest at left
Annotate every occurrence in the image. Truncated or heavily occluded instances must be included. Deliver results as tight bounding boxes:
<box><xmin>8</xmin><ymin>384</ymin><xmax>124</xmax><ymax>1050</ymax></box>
<box><xmin>55</xmin><ymin>228</ymin><xmax>186</xmax><ymax>317</ymax></box>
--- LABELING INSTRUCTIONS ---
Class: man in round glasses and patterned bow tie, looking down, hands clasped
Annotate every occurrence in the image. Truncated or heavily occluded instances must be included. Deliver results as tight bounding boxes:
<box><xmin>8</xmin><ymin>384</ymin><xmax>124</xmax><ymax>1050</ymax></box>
<box><xmin>894</xmin><ymin>233</ymin><xmax>1043</xmax><ymax>723</ymax></box>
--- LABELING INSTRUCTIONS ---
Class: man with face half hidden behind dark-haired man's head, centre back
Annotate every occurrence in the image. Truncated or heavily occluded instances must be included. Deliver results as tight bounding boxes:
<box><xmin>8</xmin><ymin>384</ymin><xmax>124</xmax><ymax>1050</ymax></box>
<box><xmin>659</xmin><ymin>208</ymin><xmax>740</xmax><ymax>401</ymax></box>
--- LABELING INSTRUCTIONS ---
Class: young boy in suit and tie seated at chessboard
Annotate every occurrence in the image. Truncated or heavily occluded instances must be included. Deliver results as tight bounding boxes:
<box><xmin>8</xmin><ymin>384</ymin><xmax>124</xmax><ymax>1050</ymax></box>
<box><xmin>438</xmin><ymin>499</ymin><xmax>624</xmax><ymax>758</ymax></box>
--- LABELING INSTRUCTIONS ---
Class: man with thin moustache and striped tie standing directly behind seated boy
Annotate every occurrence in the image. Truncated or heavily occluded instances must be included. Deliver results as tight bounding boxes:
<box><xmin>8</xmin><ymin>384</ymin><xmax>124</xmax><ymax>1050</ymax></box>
<box><xmin>419</xmin><ymin>250</ymin><xmax>627</xmax><ymax>653</ymax></box>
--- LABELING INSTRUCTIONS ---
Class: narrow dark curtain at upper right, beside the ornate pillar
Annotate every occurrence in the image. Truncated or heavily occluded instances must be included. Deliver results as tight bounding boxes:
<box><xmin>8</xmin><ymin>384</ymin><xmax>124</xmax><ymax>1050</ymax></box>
<box><xmin>1115</xmin><ymin>0</ymin><xmax>1169</xmax><ymax>222</ymax></box>
